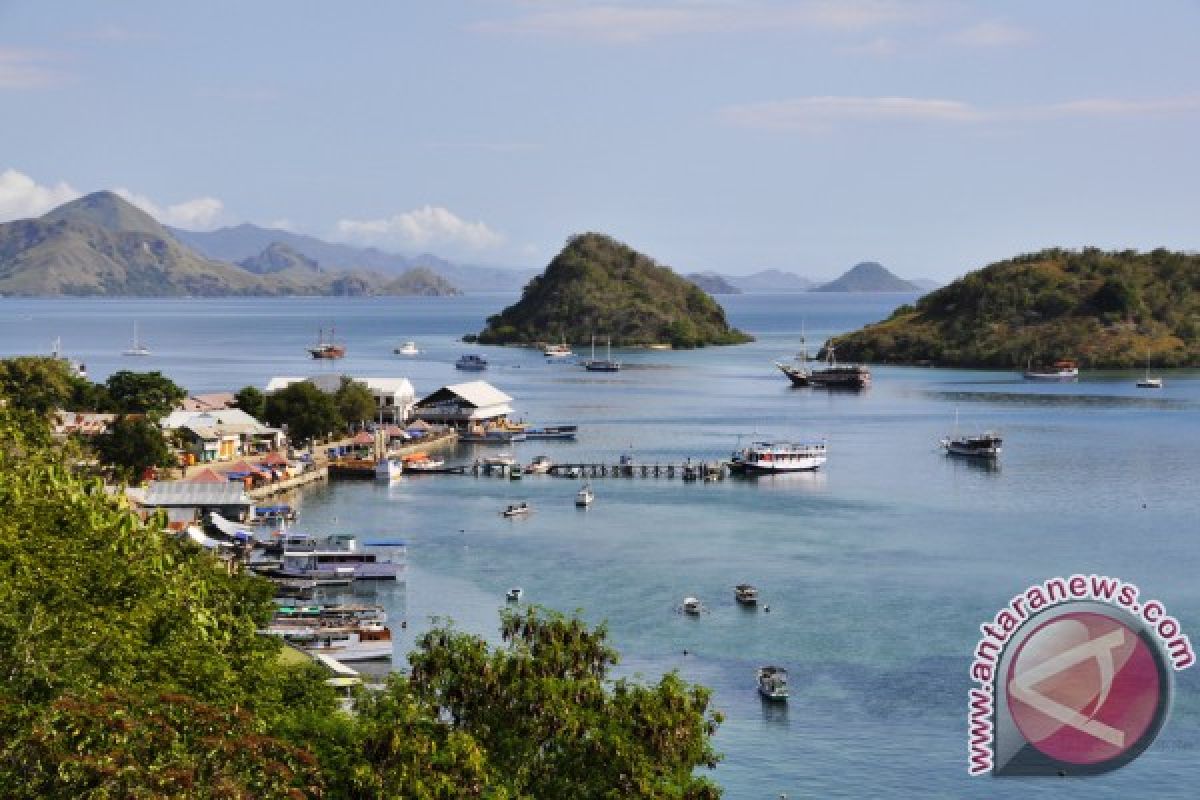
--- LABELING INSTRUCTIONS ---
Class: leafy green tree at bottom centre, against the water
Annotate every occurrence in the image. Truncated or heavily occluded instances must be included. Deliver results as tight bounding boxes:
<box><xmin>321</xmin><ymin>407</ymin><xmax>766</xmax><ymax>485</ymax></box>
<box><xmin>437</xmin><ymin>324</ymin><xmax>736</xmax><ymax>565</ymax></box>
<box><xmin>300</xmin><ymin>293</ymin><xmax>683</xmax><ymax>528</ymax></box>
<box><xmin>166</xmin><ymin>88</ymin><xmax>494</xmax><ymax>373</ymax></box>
<box><xmin>409</xmin><ymin>608</ymin><xmax>721</xmax><ymax>799</ymax></box>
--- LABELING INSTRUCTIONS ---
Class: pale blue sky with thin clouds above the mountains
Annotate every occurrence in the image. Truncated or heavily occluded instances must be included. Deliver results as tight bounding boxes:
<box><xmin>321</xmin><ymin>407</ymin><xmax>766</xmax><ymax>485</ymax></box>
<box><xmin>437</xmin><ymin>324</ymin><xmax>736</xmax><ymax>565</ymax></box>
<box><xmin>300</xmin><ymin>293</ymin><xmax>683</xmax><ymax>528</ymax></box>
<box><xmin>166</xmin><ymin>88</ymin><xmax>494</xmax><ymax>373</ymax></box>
<box><xmin>0</xmin><ymin>0</ymin><xmax>1200</xmax><ymax>281</ymax></box>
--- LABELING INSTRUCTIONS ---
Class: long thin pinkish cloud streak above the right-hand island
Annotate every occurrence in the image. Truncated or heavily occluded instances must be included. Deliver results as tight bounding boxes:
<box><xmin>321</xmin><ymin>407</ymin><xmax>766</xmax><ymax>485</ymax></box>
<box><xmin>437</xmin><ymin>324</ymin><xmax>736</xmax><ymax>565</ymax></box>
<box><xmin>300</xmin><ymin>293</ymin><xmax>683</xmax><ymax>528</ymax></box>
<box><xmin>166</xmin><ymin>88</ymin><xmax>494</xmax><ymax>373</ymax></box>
<box><xmin>719</xmin><ymin>96</ymin><xmax>1200</xmax><ymax>132</ymax></box>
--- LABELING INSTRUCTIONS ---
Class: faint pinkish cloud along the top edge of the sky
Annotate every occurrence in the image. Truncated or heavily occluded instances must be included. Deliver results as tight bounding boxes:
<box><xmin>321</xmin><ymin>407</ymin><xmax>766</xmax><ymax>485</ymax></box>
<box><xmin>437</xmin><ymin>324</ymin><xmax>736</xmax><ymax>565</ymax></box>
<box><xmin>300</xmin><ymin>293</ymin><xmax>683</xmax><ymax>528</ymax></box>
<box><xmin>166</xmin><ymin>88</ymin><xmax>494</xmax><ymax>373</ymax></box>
<box><xmin>476</xmin><ymin>0</ymin><xmax>924</xmax><ymax>43</ymax></box>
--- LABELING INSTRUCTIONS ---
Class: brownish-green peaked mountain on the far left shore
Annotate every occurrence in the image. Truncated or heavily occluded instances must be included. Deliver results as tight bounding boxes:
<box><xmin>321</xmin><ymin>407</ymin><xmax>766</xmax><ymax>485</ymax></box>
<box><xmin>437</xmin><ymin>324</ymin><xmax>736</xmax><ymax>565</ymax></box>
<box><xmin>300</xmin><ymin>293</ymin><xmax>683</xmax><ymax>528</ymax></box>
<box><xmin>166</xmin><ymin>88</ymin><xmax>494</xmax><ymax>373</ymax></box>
<box><xmin>0</xmin><ymin>192</ymin><xmax>457</xmax><ymax>296</ymax></box>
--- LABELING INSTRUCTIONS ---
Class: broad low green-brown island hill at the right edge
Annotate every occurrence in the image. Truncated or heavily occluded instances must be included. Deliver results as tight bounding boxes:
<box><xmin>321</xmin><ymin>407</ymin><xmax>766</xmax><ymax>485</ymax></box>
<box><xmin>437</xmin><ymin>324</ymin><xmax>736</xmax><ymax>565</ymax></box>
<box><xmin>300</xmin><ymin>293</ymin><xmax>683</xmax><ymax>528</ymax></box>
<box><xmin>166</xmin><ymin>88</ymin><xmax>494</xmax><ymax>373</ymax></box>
<box><xmin>838</xmin><ymin>248</ymin><xmax>1200</xmax><ymax>368</ymax></box>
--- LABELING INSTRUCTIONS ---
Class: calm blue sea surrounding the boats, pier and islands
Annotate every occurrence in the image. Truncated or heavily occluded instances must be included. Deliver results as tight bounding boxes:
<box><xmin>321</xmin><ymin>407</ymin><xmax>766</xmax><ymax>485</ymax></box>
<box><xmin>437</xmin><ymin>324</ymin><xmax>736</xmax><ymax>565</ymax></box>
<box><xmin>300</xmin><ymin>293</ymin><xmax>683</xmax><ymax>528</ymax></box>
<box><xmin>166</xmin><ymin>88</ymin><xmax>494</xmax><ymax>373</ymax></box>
<box><xmin>0</xmin><ymin>293</ymin><xmax>1200</xmax><ymax>799</ymax></box>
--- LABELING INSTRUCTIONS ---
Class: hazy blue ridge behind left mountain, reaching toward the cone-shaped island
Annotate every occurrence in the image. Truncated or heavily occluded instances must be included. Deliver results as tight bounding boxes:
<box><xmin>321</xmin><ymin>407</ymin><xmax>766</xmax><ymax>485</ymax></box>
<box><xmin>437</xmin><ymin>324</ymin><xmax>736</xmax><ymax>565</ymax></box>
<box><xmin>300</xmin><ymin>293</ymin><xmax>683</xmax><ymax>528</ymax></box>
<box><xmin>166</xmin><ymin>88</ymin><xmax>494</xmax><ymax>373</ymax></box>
<box><xmin>169</xmin><ymin>223</ymin><xmax>538</xmax><ymax>291</ymax></box>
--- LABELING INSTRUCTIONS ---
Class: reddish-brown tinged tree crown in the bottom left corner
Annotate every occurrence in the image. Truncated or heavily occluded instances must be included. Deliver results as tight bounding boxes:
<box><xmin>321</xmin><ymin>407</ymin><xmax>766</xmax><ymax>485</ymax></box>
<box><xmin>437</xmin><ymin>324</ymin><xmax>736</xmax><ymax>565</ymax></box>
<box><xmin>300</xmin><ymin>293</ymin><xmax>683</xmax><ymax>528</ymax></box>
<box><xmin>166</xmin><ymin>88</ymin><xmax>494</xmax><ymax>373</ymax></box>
<box><xmin>0</xmin><ymin>690</ymin><xmax>323</xmax><ymax>800</ymax></box>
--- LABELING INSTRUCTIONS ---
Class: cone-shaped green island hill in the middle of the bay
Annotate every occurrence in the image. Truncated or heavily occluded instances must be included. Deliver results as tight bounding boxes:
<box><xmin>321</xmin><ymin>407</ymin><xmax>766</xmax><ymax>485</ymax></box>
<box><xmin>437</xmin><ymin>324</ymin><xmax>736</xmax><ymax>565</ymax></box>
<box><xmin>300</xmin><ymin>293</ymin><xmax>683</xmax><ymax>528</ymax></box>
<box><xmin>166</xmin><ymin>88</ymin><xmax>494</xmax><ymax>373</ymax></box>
<box><xmin>479</xmin><ymin>233</ymin><xmax>751</xmax><ymax>348</ymax></box>
